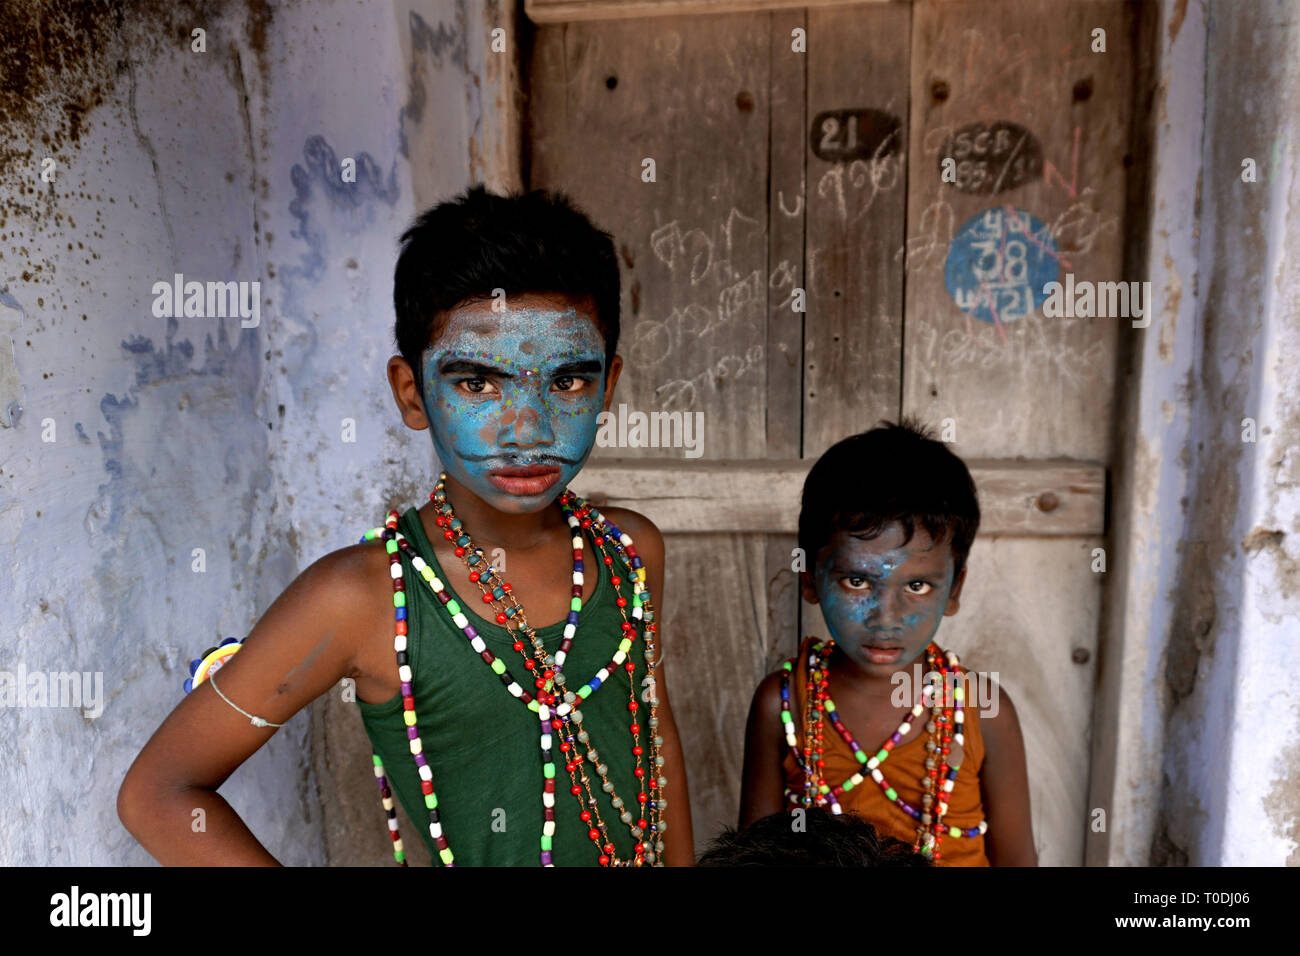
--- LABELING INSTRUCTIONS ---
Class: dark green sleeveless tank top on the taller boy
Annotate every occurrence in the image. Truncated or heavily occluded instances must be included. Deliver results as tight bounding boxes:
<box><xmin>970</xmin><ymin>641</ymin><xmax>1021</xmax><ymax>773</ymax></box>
<box><xmin>358</xmin><ymin>507</ymin><xmax>653</xmax><ymax>866</ymax></box>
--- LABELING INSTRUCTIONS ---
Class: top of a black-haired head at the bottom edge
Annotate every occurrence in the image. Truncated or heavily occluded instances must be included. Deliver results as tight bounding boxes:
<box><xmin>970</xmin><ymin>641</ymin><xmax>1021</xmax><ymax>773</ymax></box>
<box><xmin>696</xmin><ymin>806</ymin><xmax>932</xmax><ymax>866</ymax></box>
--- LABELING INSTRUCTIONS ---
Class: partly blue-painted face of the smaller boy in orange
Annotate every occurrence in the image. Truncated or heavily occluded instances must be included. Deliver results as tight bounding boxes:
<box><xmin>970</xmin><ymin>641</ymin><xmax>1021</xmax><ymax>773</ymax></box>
<box><xmin>805</xmin><ymin>522</ymin><xmax>959</xmax><ymax>676</ymax></box>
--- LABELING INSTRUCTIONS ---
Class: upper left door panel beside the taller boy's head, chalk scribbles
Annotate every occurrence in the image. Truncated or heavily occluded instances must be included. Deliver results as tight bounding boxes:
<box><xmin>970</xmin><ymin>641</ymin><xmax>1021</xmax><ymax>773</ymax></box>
<box><xmin>530</xmin><ymin>16</ymin><xmax>771</xmax><ymax>458</ymax></box>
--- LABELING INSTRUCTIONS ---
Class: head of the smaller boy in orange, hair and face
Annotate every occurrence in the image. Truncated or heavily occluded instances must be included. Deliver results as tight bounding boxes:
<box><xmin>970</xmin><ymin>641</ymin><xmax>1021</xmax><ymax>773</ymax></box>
<box><xmin>800</xmin><ymin>420</ymin><xmax>979</xmax><ymax>678</ymax></box>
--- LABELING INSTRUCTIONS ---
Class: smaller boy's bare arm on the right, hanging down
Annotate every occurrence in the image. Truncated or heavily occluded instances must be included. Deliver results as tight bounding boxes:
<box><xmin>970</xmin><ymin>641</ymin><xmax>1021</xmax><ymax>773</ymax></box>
<box><xmin>979</xmin><ymin>687</ymin><xmax>1039</xmax><ymax>866</ymax></box>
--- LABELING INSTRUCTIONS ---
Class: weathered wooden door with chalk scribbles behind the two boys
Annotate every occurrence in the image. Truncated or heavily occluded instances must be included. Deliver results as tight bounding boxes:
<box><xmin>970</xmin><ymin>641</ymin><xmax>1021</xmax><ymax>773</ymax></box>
<box><xmin>525</xmin><ymin>0</ymin><xmax>1132</xmax><ymax>865</ymax></box>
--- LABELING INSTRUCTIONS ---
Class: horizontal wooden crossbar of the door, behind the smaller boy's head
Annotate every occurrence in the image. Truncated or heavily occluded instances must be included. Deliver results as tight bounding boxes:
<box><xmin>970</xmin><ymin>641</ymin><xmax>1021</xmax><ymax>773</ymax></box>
<box><xmin>573</xmin><ymin>459</ymin><xmax>1106</xmax><ymax>536</ymax></box>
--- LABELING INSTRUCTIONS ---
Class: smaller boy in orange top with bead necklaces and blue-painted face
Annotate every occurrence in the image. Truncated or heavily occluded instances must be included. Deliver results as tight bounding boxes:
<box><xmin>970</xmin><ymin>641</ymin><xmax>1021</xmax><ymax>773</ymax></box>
<box><xmin>740</xmin><ymin>423</ymin><xmax>1037</xmax><ymax>866</ymax></box>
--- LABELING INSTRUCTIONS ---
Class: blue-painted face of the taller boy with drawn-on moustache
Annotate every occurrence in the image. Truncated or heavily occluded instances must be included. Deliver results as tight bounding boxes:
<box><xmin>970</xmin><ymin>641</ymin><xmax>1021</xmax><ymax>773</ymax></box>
<box><xmin>421</xmin><ymin>294</ymin><xmax>606</xmax><ymax>514</ymax></box>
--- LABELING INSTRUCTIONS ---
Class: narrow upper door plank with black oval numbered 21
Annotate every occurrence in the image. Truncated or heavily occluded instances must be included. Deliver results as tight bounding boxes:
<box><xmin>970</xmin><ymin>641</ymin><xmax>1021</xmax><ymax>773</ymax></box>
<box><xmin>802</xmin><ymin>4</ymin><xmax>911</xmax><ymax>458</ymax></box>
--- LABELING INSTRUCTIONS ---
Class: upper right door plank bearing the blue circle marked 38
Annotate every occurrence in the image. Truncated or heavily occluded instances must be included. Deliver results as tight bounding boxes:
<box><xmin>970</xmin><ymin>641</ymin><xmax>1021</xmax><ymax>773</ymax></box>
<box><xmin>902</xmin><ymin>0</ymin><xmax>1138</xmax><ymax>460</ymax></box>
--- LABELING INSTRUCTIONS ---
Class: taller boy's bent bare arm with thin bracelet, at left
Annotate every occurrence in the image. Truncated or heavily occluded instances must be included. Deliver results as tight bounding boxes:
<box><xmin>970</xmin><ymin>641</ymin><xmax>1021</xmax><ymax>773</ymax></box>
<box><xmin>117</xmin><ymin>545</ymin><xmax>393</xmax><ymax>866</ymax></box>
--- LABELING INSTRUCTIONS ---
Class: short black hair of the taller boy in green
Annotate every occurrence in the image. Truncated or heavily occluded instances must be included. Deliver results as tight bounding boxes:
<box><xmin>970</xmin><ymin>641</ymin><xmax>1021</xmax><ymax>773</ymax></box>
<box><xmin>393</xmin><ymin>185</ymin><xmax>620</xmax><ymax>397</ymax></box>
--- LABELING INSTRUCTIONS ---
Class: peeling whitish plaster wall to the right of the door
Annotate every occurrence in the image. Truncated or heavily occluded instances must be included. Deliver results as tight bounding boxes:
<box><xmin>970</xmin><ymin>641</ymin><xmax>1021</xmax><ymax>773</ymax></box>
<box><xmin>1170</xmin><ymin>1</ymin><xmax>1300</xmax><ymax>865</ymax></box>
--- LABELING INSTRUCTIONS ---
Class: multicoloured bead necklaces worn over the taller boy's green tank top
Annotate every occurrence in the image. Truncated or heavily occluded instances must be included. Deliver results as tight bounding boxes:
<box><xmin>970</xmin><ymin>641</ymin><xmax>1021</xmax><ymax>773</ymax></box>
<box><xmin>363</xmin><ymin>472</ymin><xmax>667</xmax><ymax>866</ymax></box>
